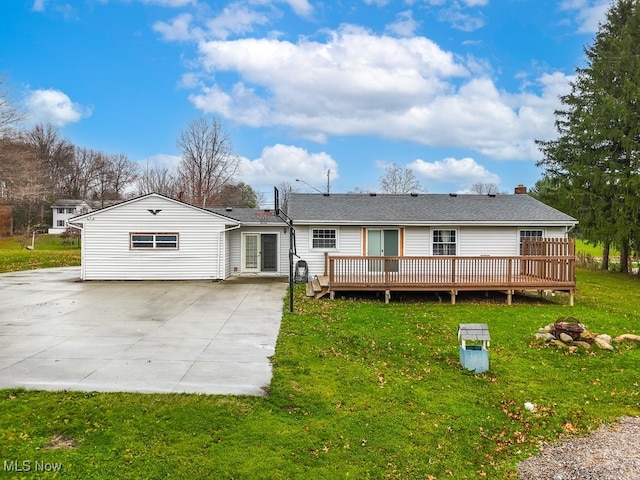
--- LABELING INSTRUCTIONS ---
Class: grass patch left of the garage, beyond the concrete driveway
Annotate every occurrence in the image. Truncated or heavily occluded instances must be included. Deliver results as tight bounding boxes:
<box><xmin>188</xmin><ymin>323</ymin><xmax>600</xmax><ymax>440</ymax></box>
<box><xmin>0</xmin><ymin>234</ymin><xmax>80</xmax><ymax>273</ymax></box>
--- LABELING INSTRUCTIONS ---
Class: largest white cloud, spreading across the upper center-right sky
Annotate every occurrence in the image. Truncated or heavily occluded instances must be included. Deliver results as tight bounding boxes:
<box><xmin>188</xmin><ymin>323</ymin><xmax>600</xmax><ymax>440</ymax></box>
<box><xmin>182</xmin><ymin>26</ymin><xmax>569</xmax><ymax>160</ymax></box>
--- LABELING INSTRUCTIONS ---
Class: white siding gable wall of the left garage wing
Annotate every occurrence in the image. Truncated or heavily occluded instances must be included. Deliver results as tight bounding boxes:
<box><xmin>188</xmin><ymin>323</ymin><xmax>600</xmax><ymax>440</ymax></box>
<box><xmin>82</xmin><ymin>196</ymin><xmax>226</xmax><ymax>280</ymax></box>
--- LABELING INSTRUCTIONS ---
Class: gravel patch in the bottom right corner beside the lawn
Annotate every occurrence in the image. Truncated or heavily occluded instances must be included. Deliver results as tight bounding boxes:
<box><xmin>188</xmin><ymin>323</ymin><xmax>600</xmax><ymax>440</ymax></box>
<box><xmin>518</xmin><ymin>417</ymin><xmax>640</xmax><ymax>480</ymax></box>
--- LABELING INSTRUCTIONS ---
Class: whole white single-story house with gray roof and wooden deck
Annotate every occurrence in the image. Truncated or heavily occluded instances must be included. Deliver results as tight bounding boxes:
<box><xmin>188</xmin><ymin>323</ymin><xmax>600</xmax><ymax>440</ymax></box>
<box><xmin>71</xmin><ymin>186</ymin><xmax>577</xmax><ymax>299</ymax></box>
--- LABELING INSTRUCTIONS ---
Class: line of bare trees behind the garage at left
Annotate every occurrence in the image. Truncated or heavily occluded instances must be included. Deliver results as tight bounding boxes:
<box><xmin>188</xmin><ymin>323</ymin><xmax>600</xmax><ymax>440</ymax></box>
<box><xmin>0</xmin><ymin>79</ymin><xmax>260</xmax><ymax>232</ymax></box>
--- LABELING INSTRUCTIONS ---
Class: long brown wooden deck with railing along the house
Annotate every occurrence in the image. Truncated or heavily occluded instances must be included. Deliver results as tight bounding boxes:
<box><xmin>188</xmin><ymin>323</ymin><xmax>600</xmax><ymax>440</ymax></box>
<box><xmin>308</xmin><ymin>240</ymin><xmax>576</xmax><ymax>305</ymax></box>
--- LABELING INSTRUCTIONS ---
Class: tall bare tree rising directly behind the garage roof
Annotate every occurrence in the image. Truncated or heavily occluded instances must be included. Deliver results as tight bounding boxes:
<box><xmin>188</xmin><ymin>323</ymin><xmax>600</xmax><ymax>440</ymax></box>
<box><xmin>178</xmin><ymin>117</ymin><xmax>239</xmax><ymax>207</ymax></box>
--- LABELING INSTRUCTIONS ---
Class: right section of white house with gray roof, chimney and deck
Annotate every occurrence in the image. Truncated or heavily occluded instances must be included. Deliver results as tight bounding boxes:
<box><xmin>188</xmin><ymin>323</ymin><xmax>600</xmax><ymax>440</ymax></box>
<box><xmin>288</xmin><ymin>186</ymin><xmax>577</xmax><ymax>303</ymax></box>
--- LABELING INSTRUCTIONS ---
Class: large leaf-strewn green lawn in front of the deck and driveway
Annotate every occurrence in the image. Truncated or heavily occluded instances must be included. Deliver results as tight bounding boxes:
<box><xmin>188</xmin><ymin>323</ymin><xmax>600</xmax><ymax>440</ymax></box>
<box><xmin>0</xmin><ymin>270</ymin><xmax>640</xmax><ymax>479</ymax></box>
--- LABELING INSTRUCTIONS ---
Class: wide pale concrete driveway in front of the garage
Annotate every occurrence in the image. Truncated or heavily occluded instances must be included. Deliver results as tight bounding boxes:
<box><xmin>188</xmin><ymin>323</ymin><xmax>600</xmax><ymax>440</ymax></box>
<box><xmin>0</xmin><ymin>267</ymin><xmax>287</xmax><ymax>395</ymax></box>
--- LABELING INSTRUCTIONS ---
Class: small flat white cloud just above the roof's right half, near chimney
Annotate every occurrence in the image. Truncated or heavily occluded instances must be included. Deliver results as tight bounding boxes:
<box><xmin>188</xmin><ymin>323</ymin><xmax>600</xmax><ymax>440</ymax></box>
<box><xmin>407</xmin><ymin>157</ymin><xmax>500</xmax><ymax>187</ymax></box>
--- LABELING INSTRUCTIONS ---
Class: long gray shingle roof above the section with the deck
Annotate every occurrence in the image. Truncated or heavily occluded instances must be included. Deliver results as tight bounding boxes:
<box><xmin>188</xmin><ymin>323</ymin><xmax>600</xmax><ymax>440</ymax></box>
<box><xmin>289</xmin><ymin>194</ymin><xmax>578</xmax><ymax>225</ymax></box>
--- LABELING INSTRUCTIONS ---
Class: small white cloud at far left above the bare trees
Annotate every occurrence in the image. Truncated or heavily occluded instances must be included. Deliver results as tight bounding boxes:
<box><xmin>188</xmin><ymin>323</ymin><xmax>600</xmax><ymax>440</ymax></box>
<box><xmin>25</xmin><ymin>89</ymin><xmax>92</xmax><ymax>127</ymax></box>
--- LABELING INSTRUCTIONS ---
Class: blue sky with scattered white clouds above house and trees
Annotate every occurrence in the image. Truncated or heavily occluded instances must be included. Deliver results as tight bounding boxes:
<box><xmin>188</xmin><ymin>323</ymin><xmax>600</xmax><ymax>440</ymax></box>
<box><xmin>0</xmin><ymin>0</ymin><xmax>610</xmax><ymax>202</ymax></box>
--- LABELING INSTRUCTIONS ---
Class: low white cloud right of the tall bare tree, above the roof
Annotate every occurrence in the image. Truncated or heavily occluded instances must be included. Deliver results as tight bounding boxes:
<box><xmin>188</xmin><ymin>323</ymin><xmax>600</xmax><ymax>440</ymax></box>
<box><xmin>238</xmin><ymin>144</ymin><xmax>339</xmax><ymax>190</ymax></box>
